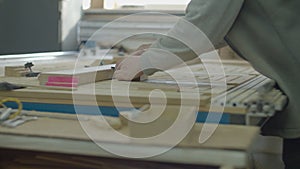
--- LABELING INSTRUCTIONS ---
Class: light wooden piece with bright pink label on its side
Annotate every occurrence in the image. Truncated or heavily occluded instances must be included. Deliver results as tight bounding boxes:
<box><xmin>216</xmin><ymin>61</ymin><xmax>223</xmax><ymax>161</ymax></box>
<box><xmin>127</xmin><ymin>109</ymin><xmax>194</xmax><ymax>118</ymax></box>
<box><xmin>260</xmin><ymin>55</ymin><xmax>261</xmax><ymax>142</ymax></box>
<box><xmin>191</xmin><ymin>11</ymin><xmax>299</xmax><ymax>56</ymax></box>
<box><xmin>38</xmin><ymin>64</ymin><xmax>115</xmax><ymax>85</ymax></box>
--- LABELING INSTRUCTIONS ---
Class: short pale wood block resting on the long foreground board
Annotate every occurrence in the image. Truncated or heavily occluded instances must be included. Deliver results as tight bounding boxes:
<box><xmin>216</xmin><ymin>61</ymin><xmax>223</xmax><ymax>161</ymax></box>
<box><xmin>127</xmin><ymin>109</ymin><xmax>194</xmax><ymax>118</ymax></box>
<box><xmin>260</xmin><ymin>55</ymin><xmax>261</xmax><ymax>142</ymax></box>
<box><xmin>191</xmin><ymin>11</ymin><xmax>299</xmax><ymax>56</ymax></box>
<box><xmin>119</xmin><ymin>105</ymin><xmax>198</xmax><ymax>138</ymax></box>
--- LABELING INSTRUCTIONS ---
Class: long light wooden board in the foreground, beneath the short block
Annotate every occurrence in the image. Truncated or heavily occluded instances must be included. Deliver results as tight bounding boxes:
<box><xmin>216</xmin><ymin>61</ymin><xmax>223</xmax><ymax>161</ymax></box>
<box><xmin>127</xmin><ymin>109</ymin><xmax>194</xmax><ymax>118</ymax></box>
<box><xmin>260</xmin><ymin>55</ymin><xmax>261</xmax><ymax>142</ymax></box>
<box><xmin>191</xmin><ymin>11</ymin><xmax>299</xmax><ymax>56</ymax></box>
<box><xmin>0</xmin><ymin>111</ymin><xmax>259</xmax><ymax>151</ymax></box>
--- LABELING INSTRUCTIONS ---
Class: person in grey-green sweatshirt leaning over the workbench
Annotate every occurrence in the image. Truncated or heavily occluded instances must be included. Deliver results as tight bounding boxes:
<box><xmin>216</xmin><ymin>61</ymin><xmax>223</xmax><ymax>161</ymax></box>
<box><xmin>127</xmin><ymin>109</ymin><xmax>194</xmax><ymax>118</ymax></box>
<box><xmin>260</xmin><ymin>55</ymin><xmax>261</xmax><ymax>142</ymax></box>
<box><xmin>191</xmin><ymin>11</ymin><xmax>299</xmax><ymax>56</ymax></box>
<box><xmin>115</xmin><ymin>0</ymin><xmax>300</xmax><ymax>169</ymax></box>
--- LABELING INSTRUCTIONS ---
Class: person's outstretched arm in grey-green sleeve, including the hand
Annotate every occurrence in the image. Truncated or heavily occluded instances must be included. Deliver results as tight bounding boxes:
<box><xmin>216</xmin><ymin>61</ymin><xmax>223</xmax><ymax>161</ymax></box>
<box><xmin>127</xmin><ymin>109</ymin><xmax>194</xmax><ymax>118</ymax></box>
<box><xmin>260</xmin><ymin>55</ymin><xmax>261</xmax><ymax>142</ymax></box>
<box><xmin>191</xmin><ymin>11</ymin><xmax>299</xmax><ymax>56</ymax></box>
<box><xmin>115</xmin><ymin>0</ymin><xmax>243</xmax><ymax>80</ymax></box>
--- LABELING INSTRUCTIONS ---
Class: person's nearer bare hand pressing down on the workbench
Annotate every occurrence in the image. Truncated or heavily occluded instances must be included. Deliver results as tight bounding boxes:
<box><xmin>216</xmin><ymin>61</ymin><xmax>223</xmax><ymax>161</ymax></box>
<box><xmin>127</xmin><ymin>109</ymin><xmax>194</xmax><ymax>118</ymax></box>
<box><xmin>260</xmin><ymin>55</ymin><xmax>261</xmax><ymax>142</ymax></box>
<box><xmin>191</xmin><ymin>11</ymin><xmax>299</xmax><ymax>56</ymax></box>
<box><xmin>114</xmin><ymin>55</ymin><xmax>143</xmax><ymax>81</ymax></box>
